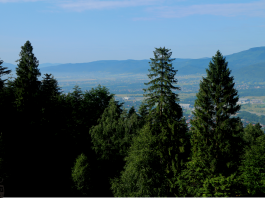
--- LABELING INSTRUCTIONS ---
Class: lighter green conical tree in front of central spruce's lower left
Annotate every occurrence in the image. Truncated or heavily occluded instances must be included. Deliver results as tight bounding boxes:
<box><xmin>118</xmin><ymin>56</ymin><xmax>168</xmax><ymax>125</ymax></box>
<box><xmin>111</xmin><ymin>123</ymin><xmax>166</xmax><ymax>198</ymax></box>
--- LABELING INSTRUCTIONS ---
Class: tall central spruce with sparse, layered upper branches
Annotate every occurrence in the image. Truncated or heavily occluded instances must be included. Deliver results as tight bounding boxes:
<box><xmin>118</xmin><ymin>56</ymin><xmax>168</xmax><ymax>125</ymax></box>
<box><xmin>143</xmin><ymin>47</ymin><xmax>188</xmax><ymax>196</ymax></box>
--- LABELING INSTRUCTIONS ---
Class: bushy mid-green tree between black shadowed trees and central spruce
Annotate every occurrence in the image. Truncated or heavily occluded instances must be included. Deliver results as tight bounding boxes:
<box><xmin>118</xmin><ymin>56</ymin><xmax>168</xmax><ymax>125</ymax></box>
<box><xmin>89</xmin><ymin>98</ymin><xmax>139</xmax><ymax>193</ymax></box>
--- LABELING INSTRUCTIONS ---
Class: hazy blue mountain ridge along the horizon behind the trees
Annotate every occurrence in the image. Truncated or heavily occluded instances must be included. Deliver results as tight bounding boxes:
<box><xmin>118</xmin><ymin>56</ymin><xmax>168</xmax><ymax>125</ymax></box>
<box><xmin>3</xmin><ymin>47</ymin><xmax>265</xmax><ymax>81</ymax></box>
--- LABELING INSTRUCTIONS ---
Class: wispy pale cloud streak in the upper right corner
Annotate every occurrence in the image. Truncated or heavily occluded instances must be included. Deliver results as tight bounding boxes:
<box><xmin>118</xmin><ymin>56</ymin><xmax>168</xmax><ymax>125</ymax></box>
<box><xmin>147</xmin><ymin>0</ymin><xmax>265</xmax><ymax>18</ymax></box>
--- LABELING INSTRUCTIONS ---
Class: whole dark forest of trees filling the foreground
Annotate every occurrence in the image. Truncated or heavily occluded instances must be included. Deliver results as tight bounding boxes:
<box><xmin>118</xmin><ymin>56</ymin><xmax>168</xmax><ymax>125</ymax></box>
<box><xmin>0</xmin><ymin>41</ymin><xmax>265</xmax><ymax>198</ymax></box>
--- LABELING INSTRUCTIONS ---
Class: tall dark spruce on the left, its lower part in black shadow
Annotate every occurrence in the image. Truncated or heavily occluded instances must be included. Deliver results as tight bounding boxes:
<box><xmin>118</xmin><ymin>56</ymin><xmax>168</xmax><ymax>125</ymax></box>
<box><xmin>10</xmin><ymin>41</ymin><xmax>42</xmax><ymax>197</ymax></box>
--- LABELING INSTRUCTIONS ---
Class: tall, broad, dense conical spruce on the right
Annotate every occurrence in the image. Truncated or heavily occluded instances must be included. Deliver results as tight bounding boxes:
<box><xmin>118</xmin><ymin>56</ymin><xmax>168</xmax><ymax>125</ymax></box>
<box><xmin>175</xmin><ymin>51</ymin><xmax>244</xmax><ymax>198</ymax></box>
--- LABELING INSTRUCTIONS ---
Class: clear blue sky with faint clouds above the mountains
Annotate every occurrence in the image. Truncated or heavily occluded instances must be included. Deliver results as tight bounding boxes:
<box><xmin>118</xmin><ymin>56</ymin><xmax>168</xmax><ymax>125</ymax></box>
<box><xmin>0</xmin><ymin>0</ymin><xmax>265</xmax><ymax>64</ymax></box>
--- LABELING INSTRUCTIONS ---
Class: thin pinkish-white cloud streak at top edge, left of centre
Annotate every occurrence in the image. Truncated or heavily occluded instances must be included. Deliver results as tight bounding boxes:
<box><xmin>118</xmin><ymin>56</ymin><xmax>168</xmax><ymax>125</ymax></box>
<box><xmin>60</xmin><ymin>0</ymin><xmax>159</xmax><ymax>11</ymax></box>
